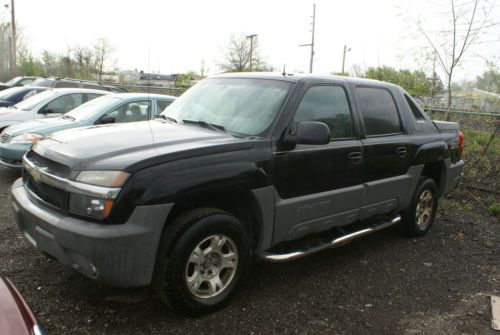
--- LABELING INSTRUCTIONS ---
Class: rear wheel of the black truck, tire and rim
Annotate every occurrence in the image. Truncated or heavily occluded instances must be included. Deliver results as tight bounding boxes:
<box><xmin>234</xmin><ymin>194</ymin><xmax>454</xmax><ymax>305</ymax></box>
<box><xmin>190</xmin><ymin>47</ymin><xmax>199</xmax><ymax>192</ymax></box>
<box><xmin>401</xmin><ymin>177</ymin><xmax>438</xmax><ymax>237</ymax></box>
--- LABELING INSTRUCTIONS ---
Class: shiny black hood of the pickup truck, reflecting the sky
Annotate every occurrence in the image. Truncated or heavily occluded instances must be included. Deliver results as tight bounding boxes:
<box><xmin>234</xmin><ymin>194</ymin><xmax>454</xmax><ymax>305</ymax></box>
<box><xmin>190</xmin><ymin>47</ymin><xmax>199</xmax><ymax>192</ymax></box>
<box><xmin>34</xmin><ymin>120</ymin><xmax>251</xmax><ymax>171</ymax></box>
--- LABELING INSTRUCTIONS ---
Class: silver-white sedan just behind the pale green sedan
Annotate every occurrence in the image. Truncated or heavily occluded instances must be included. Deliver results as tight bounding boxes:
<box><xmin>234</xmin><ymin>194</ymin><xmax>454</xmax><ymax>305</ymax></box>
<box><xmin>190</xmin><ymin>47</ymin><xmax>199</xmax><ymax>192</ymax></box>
<box><xmin>0</xmin><ymin>88</ymin><xmax>111</xmax><ymax>132</ymax></box>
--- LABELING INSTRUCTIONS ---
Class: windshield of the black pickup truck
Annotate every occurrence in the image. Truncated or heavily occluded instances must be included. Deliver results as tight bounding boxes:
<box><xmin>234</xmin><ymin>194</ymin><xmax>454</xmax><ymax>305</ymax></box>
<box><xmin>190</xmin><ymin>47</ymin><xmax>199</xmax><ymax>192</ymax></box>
<box><xmin>162</xmin><ymin>78</ymin><xmax>291</xmax><ymax>135</ymax></box>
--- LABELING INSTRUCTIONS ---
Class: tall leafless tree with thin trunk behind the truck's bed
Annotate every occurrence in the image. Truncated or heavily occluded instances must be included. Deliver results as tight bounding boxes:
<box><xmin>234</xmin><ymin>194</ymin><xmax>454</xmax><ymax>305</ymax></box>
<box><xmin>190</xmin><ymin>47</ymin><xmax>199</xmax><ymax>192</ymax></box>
<box><xmin>413</xmin><ymin>0</ymin><xmax>498</xmax><ymax>108</ymax></box>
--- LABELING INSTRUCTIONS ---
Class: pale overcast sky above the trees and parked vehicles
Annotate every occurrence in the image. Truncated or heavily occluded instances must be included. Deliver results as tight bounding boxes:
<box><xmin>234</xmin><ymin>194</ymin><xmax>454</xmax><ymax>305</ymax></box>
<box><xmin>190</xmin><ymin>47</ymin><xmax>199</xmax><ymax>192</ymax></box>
<box><xmin>0</xmin><ymin>0</ymin><xmax>500</xmax><ymax>80</ymax></box>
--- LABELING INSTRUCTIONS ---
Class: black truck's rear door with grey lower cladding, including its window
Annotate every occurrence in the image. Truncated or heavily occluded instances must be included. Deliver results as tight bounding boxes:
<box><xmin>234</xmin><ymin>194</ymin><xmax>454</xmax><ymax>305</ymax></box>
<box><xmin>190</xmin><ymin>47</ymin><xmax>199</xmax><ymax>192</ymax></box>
<box><xmin>355</xmin><ymin>86</ymin><xmax>410</xmax><ymax>219</ymax></box>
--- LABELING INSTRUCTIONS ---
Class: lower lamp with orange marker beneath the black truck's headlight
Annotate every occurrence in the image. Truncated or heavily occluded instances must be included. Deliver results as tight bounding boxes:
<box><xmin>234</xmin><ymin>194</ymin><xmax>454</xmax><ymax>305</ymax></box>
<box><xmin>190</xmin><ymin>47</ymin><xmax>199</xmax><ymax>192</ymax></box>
<box><xmin>69</xmin><ymin>194</ymin><xmax>113</xmax><ymax>219</ymax></box>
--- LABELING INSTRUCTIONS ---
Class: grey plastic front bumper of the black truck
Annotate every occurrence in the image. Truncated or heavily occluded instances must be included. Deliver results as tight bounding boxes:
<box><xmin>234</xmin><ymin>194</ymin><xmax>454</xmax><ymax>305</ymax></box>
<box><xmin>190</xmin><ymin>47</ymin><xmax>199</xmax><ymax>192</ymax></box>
<box><xmin>12</xmin><ymin>179</ymin><xmax>173</xmax><ymax>287</ymax></box>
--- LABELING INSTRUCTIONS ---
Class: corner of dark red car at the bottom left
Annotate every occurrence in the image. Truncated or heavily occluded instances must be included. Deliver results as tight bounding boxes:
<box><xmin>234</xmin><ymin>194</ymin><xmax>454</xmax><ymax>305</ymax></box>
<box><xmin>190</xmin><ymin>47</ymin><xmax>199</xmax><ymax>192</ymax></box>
<box><xmin>0</xmin><ymin>277</ymin><xmax>45</xmax><ymax>335</ymax></box>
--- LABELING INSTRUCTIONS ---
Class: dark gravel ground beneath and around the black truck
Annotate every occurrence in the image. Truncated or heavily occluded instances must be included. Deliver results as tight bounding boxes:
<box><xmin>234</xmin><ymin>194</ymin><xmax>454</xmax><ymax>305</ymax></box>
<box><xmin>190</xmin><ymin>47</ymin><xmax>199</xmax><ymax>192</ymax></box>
<box><xmin>0</xmin><ymin>168</ymin><xmax>500</xmax><ymax>335</ymax></box>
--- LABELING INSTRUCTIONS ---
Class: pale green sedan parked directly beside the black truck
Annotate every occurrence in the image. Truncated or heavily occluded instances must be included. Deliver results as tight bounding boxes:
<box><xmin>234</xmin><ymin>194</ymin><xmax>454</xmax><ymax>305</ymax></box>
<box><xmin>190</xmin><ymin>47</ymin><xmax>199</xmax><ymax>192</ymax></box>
<box><xmin>0</xmin><ymin>93</ymin><xmax>175</xmax><ymax>170</ymax></box>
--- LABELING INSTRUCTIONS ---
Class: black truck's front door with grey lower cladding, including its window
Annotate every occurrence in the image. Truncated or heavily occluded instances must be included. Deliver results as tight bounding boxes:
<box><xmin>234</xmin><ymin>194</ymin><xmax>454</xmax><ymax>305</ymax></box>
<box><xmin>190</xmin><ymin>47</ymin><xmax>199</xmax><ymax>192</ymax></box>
<box><xmin>273</xmin><ymin>85</ymin><xmax>363</xmax><ymax>243</ymax></box>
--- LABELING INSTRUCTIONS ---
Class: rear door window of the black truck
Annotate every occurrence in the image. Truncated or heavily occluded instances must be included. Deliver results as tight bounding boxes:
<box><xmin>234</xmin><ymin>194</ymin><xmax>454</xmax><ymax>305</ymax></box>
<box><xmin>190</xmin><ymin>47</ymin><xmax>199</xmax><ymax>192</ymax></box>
<box><xmin>356</xmin><ymin>87</ymin><xmax>401</xmax><ymax>136</ymax></box>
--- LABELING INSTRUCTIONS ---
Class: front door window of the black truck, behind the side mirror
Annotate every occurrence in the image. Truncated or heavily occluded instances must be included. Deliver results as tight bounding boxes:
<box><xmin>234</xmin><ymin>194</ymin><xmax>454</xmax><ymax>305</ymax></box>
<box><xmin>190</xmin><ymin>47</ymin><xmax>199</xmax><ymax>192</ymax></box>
<box><xmin>293</xmin><ymin>86</ymin><xmax>354</xmax><ymax>139</ymax></box>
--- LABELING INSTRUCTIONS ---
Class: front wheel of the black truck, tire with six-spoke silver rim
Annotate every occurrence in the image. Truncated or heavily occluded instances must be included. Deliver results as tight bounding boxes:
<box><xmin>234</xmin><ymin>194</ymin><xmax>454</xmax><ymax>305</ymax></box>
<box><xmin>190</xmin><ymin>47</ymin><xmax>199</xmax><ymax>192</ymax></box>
<box><xmin>155</xmin><ymin>208</ymin><xmax>252</xmax><ymax>315</ymax></box>
